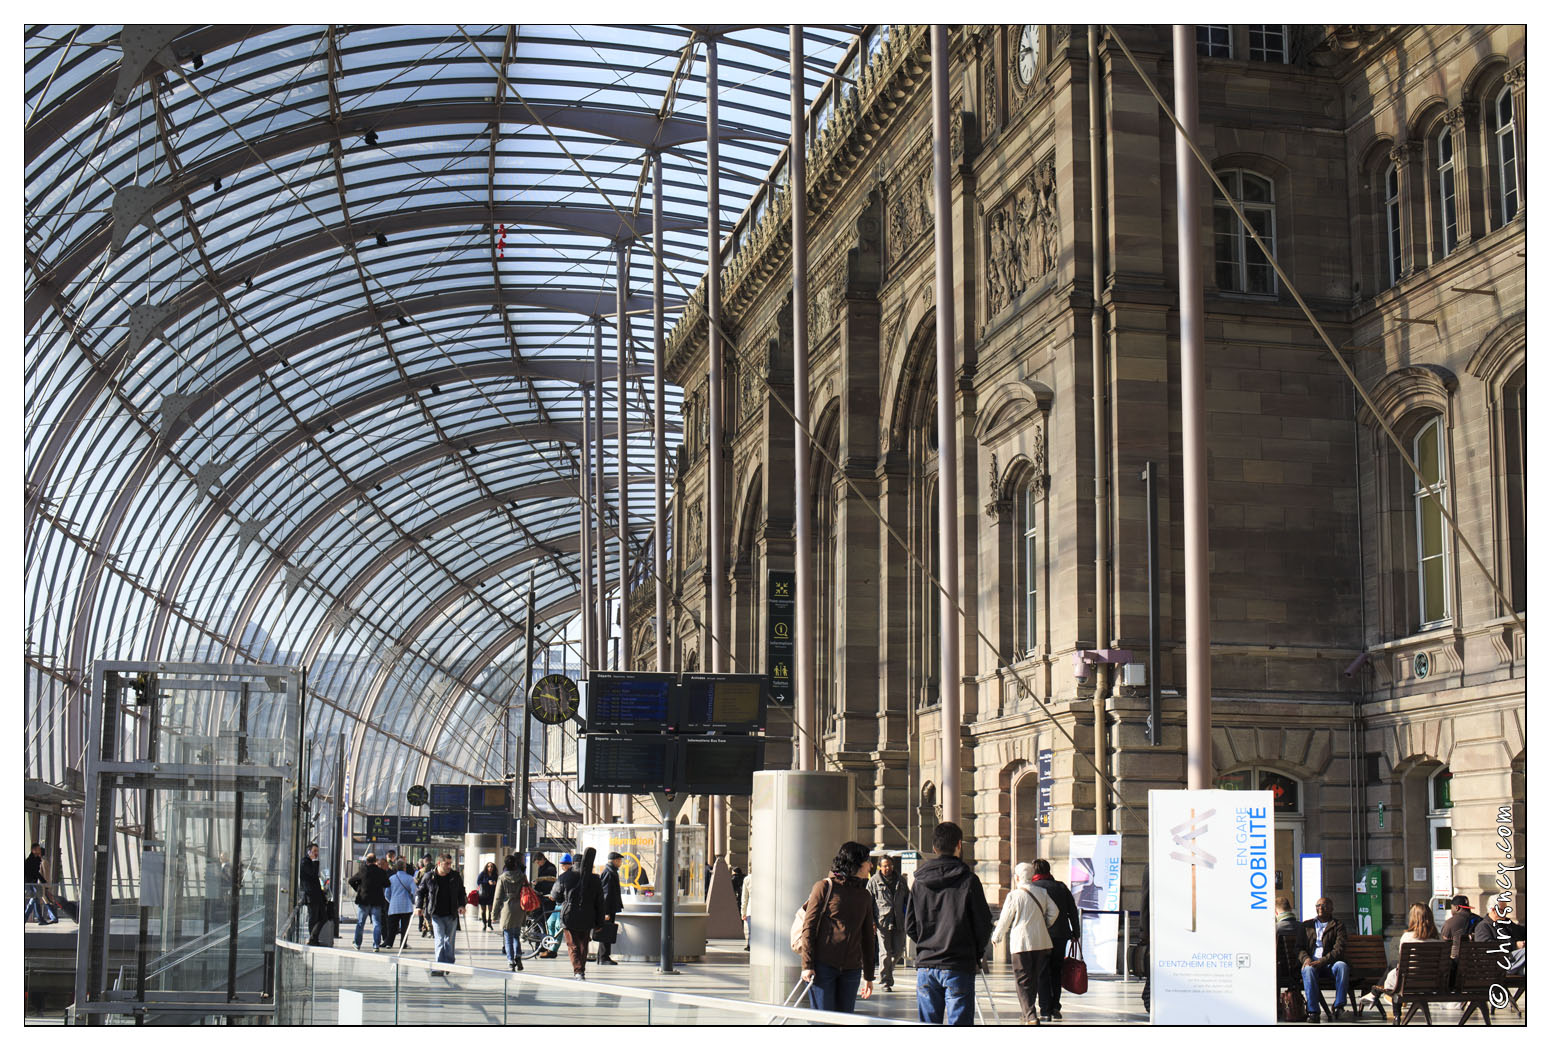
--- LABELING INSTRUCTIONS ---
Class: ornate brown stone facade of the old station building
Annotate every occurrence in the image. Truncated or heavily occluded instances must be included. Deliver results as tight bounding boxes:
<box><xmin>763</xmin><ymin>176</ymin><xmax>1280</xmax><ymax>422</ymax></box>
<box><xmin>637</xmin><ymin>25</ymin><xmax>1525</xmax><ymax>927</ymax></box>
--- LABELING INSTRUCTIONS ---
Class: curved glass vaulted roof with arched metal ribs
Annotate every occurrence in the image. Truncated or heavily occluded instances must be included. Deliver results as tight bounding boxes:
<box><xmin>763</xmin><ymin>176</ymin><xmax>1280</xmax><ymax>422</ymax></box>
<box><xmin>23</xmin><ymin>25</ymin><xmax>881</xmax><ymax>811</ymax></box>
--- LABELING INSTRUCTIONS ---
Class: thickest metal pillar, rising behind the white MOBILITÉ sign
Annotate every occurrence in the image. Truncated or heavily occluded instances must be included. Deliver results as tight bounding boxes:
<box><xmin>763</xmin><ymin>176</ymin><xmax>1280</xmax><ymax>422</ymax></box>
<box><xmin>1174</xmin><ymin>25</ymin><xmax>1211</xmax><ymax>789</ymax></box>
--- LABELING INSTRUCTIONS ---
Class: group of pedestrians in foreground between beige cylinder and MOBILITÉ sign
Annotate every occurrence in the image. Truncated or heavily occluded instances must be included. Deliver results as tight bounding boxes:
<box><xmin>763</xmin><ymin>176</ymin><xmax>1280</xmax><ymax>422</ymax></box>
<box><xmin>800</xmin><ymin>822</ymin><xmax>1081</xmax><ymax>1025</ymax></box>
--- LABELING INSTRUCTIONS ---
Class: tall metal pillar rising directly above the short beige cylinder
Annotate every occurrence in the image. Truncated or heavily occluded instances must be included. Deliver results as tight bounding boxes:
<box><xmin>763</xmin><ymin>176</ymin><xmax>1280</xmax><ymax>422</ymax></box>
<box><xmin>786</xmin><ymin>25</ymin><xmax>817</xmax><ymax>770</ymax></box>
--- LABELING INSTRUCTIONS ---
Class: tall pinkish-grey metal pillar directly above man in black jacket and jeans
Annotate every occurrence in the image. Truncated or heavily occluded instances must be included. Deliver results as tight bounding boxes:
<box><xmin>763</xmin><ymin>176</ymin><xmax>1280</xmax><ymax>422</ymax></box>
<box><xmin>932</xmin><ymin>25</ymin><xmax>962</xmax><ymax>823</ymax></box>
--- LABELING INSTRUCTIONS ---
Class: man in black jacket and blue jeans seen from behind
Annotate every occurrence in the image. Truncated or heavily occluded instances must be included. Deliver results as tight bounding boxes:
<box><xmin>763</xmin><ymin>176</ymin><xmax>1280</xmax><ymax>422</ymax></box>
<box><xmin>904</xmin><ymin>822</ymin><xmax>991</xmax><ymax>1026</ymax></box>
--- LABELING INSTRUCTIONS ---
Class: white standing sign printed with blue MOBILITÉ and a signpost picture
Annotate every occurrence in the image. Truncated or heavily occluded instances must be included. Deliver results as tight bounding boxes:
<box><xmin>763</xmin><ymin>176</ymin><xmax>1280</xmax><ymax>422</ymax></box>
<box><xmin>1148</xmin><ymin>789</ymin><xmax>1276</xmax><ymax>1025</ymax></box>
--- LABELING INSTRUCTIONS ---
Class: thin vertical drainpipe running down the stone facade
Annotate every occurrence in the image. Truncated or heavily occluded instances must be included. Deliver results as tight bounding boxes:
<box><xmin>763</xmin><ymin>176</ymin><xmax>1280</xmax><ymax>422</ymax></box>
<box><xmin>1087</xmin><ymin>25</ymin><xmax>1112</xmax><ymax>836</ymax></box>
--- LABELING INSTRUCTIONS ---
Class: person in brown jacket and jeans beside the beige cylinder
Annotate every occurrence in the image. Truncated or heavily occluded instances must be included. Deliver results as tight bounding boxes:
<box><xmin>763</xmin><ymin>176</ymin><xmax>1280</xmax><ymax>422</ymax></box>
<box><xmin>802</xmin><ymin>842</ymin><xmax>878</xmax><ymax>1014</ymax></box>
